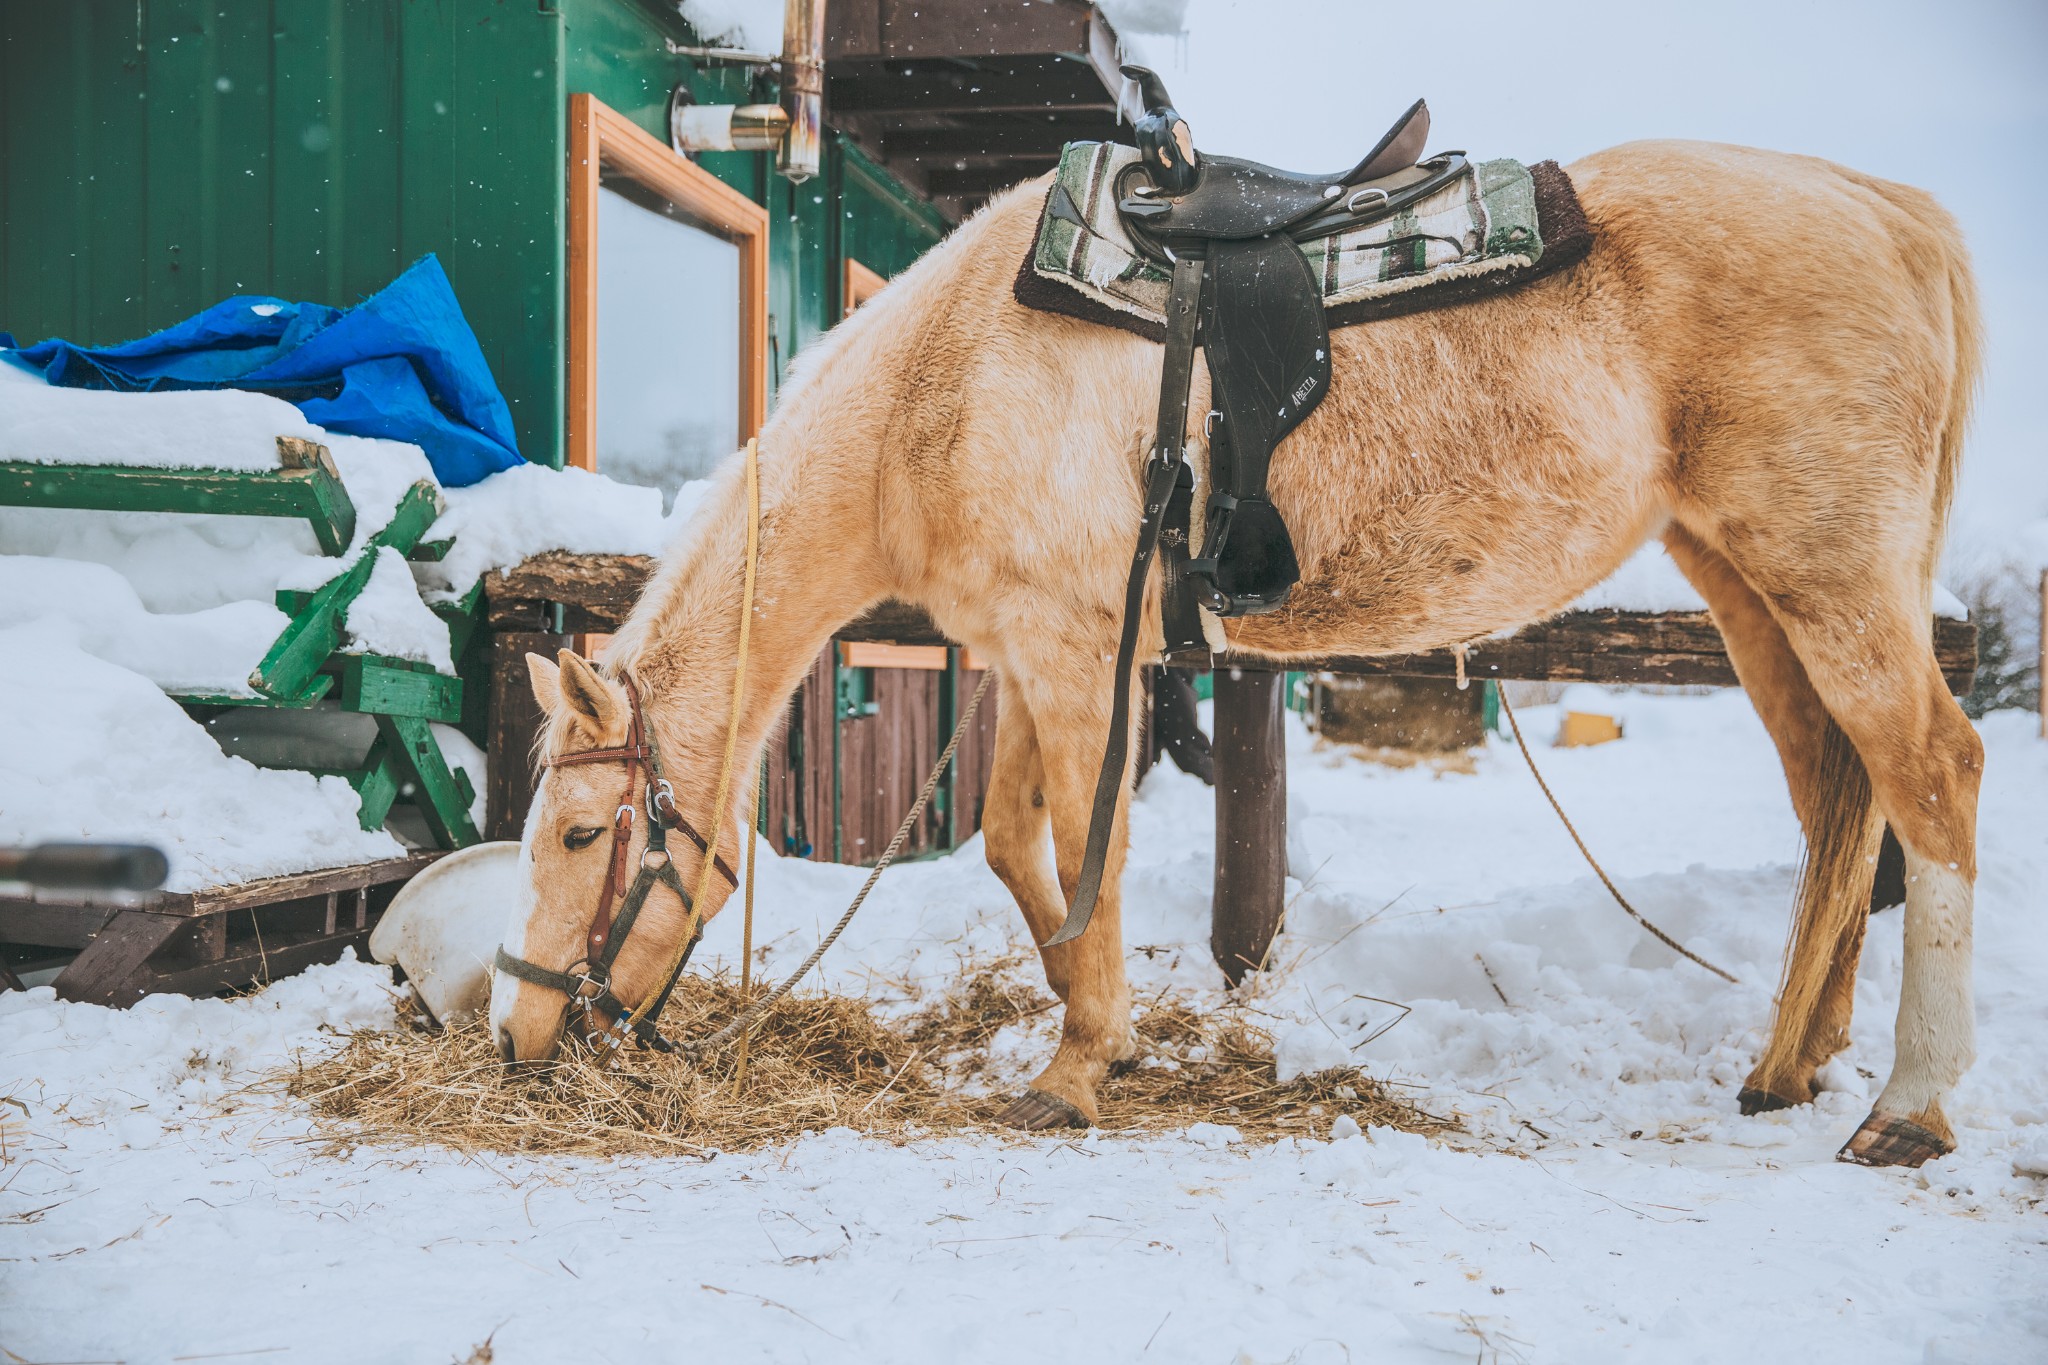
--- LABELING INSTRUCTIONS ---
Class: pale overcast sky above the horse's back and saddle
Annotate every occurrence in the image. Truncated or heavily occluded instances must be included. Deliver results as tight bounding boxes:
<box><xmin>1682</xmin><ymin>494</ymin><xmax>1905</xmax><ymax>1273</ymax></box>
<box><xmin>1106</xmin><ymin>0</ymin><xmax>2048</xmax><ymax>567</ymax></box>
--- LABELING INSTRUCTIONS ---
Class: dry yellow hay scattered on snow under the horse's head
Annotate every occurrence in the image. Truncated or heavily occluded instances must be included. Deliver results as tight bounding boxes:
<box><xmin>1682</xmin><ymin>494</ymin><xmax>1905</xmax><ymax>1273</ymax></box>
<box><xmin>274</xmin><ymin>966</ymin><xmax>1452</xmax><ymax>1156</ymax></box>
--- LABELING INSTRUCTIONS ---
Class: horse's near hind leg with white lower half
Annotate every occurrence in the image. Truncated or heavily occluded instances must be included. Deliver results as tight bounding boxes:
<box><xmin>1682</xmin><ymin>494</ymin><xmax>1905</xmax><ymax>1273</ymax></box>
<box><xmin>1718</xmin><ymin>527</ymin><xmax>1985</xmax><ymax>1166</ymax></box>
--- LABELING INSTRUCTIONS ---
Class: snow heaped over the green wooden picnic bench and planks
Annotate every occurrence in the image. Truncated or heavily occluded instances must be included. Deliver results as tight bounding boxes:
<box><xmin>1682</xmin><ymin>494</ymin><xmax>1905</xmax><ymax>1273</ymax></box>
<box><xmin>0</xmin><ymin>382</ymin><xmax>709</xmax><ymax>890</ymax></box>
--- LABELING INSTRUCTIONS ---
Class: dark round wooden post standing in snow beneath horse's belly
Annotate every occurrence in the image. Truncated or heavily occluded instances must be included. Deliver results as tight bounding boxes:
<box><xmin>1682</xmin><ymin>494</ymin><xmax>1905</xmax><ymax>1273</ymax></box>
<box><xmin>1208</xmin><ymin>667</ymin><xmax>1286</xmax><ymax>986</ymax></box>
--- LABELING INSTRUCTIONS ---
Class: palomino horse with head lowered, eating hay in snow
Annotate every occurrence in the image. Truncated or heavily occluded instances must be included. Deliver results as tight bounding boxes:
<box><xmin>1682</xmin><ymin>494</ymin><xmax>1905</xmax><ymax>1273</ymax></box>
<box><xmin>492</xmin><ymin>141</ymin><xmax>1982</xmax><ymax>1164</ymax></box>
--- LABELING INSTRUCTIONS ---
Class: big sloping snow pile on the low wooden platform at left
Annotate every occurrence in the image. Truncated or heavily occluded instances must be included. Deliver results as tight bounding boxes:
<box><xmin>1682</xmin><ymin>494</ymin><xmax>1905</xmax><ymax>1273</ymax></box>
<box><xmin>0</xmin><ymin>628</ymin><xmax>406</xmax><ymax>890</ymax></box>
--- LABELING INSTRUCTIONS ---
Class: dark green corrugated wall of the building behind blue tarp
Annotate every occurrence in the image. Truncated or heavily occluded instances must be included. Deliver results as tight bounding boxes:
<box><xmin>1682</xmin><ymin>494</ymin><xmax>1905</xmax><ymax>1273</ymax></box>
<box><xmin>0</xmin><ymin>0</ymin><xmax>944</xmax><ymax>463</ymax></box>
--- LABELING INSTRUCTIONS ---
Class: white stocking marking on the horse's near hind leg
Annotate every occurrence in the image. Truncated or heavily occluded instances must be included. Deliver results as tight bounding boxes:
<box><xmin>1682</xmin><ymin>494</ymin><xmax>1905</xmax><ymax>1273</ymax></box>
<box><xmin>1876</xmin><ymin>849</ymin><xmax>1976</xmax><ymax>1117</ymax></box>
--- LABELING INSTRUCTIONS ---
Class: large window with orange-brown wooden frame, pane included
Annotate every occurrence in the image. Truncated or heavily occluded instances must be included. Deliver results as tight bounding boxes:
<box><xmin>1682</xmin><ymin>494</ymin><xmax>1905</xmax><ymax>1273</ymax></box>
<box><xmin>565</xmin><ymin>94</ymin><xmax>768</xmax><ymax>499</ymax></box>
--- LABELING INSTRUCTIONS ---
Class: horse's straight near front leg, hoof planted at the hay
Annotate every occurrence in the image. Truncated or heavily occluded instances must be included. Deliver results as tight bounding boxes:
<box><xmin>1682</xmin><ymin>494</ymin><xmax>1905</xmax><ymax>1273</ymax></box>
<box><xmin>991</xmin><ymin>669</ymin><xmax>1137</xmax><ymax>1128</ymax></box>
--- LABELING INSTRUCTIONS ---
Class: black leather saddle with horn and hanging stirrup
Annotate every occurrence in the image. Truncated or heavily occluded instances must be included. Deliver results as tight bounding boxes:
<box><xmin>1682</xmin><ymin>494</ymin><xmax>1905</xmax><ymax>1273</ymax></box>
<box><xmin>1116</xmin><ymin>65</ymin><xmax>1466</xmax><ymax>622</ymax></box>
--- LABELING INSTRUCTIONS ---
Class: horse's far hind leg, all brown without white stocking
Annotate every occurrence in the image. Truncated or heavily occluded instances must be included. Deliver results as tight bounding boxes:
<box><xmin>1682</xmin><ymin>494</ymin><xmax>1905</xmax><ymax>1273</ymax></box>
<box><xmin>1665</xmin><ymin>526</ymin><xmax>1872</xmax><ymax>1113</ymax></box>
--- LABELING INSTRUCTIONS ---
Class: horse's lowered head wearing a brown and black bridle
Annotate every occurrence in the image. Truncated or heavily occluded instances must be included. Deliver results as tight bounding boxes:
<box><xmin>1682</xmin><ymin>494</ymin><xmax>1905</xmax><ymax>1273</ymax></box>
<box><xmin>492</xmin><ymin>649</ymin><xmax>725</xmax><ymax>1062</ymax></box>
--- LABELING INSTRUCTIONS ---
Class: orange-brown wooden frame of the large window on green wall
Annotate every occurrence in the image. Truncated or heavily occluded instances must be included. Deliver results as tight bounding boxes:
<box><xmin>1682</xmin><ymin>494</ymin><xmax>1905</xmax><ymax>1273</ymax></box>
<box><xmin>563</xmin><ymin>94</ymin><xmax>768</xmax><ymax>469</ymax></box>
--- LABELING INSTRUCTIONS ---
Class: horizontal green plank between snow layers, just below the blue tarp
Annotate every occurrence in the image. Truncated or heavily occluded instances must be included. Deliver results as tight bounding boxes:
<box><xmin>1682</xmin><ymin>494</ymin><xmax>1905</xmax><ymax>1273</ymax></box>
<box><xmin>0</xmin><ymin>460</ymin><xmax>356</xmax><ymax>555</ymax></box>
